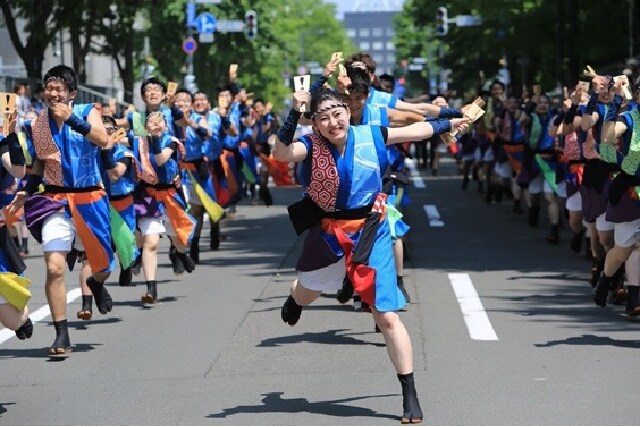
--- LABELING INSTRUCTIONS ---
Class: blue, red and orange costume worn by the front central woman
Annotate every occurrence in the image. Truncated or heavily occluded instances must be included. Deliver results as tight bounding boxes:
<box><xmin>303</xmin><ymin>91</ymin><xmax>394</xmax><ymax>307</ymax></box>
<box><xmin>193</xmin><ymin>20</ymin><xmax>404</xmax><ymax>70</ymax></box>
<box><xmin>290</xmin><ymin>126</ymin><xmax>405</xmax><ymax>312</ymax></box>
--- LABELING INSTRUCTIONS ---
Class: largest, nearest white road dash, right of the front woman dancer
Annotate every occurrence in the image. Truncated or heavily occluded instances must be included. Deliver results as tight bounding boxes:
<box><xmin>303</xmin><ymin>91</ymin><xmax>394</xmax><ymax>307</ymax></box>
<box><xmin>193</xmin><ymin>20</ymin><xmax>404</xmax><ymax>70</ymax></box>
<box><xmin>449</xmin><ymin>273</ymin><xmax>498</xmax><ymax>341</ymax></box>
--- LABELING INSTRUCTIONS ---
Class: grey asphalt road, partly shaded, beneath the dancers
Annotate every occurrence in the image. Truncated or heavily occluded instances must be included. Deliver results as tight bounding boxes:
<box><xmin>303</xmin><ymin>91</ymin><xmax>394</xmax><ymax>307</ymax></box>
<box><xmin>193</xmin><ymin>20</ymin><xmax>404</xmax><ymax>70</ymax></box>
<box><xmin>0</xmin><ymin>162</ymin><xmax>640</xmax><ymax>425</ymax></box>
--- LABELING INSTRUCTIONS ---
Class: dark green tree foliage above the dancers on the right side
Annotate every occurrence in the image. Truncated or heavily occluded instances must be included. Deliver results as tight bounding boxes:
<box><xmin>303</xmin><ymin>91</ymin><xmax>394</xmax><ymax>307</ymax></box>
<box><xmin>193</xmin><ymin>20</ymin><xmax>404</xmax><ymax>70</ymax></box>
<box><xmin>396</xmin><ymin>0</ymin><xmax>640</xmax><ymax>98</ymax></box>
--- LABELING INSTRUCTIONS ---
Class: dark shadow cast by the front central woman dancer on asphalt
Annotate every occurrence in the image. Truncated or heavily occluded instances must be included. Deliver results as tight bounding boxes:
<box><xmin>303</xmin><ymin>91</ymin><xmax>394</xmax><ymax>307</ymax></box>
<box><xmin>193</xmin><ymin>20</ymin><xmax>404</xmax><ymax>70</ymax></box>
<box><xmin>207</xmin><ymin>391</ymin><xmax>399</xmax><ymax>421</ymax></box>
